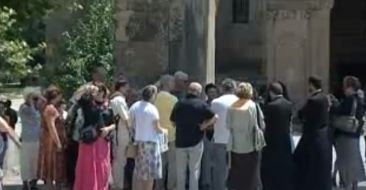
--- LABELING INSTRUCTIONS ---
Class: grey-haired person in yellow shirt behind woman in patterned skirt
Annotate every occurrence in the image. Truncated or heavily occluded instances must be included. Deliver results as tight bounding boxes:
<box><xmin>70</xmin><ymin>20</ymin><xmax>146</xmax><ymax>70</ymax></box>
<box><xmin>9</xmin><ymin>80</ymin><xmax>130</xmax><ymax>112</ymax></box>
<box><xmin>155</xmin><ymin>75</ymin><xmax>178</xmax><ymax>190</ymax></box>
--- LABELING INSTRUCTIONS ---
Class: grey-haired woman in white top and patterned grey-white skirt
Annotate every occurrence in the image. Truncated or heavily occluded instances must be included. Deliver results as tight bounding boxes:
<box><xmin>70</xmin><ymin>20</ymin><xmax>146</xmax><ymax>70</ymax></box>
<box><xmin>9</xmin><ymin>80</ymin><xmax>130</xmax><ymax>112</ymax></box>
<box><xmin>130</xmin><ymin>85</ymin><xmax>167</xmax><ymax>190</ymax></box>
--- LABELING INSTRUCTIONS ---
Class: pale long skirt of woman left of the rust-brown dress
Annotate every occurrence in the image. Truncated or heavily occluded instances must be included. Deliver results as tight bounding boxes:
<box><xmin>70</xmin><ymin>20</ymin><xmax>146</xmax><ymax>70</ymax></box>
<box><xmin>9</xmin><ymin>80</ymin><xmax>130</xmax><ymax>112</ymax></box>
<box><xmin>20</xmin><ymin>142</ymin><xmax>39</xmax><ymax>181</ymax></box>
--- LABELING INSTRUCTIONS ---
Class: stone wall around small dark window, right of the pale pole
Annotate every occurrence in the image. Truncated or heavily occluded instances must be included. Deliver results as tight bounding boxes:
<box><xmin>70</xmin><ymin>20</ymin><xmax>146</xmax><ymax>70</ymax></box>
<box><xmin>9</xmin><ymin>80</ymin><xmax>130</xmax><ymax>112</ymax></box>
<box><xmin>216</xmin><ymin>0</ymin><xmax>266</xmax><ymax>80</ymax></box>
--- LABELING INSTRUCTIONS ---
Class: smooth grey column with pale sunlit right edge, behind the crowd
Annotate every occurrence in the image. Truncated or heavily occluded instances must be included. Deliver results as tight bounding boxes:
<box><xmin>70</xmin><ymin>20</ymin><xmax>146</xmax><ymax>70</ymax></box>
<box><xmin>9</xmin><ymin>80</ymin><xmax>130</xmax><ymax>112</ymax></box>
<box><xmin>182</xmin><ymin>0</ymin><xmax>215</xmax><ymax>83</ymax></box>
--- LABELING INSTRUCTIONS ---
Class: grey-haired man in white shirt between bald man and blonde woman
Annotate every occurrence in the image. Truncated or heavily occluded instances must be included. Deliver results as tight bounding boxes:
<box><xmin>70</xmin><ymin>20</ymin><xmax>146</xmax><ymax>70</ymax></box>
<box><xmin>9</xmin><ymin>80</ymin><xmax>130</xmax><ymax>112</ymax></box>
<box><xmin>211</xmin><ymin>78</ymin><xmax>239</xmax><ymax>190</ymax></box>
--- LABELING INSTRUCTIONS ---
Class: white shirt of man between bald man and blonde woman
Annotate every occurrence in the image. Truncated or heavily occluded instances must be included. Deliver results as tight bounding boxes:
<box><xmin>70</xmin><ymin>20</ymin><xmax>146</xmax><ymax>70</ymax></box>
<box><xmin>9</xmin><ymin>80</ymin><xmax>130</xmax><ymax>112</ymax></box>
<box><xmin>211</xmin><ymin>94</ymin><xmax>239</xmax><ymax>144</ymax></box>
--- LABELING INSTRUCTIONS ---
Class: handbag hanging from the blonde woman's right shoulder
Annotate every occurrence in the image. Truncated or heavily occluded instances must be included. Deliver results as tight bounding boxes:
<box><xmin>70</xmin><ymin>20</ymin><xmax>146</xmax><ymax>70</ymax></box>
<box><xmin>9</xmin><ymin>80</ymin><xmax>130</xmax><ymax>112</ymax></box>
<box><xmin>253</xmin><ymin>104</ymin><xmax>267</xmax><ymax>151</ymax></box>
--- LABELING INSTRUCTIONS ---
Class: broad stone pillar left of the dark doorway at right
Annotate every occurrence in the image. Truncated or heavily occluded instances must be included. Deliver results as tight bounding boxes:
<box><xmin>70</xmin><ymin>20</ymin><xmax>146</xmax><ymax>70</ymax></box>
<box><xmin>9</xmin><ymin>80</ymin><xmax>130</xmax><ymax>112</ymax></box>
<box><xmin>267</xmin><ymin>10</ymin><xmax>309</xmax><ymax>104</ymax></box>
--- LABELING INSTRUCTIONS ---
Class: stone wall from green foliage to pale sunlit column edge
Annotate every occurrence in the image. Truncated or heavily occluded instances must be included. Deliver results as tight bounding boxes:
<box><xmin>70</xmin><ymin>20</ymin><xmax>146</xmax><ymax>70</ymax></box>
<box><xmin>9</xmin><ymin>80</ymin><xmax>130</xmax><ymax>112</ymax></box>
<box><xmin>116</xmin><ymin>0</ymin><xmax>216</xmax><ymax>86</ymax></box>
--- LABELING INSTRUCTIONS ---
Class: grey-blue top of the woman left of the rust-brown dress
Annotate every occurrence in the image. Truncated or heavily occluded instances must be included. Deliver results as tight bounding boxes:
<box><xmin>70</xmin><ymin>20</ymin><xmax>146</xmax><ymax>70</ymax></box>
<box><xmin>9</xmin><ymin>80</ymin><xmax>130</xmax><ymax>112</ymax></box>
<box><xmin>19</xmin><ymin>104</ymin><xmax>42</xmax><ymax>142</ymax></box>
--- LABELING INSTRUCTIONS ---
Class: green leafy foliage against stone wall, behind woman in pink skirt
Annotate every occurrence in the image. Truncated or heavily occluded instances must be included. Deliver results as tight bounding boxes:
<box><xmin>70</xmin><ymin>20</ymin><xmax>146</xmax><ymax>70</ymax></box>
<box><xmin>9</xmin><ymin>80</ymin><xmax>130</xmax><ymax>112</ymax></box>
<box><xmin>53</xmin><ymin>0</ymin><xmax>116</xmax><ymax>97</ymax></box>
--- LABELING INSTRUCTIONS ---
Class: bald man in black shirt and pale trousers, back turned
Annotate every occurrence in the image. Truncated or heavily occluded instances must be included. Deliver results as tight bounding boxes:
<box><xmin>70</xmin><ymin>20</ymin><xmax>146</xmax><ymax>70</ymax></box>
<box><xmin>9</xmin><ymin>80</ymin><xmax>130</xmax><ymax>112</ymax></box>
<box><xmin>170</xmin><ymin>82</ymin><xmax>217</xmax><ymax>190</ymax></box>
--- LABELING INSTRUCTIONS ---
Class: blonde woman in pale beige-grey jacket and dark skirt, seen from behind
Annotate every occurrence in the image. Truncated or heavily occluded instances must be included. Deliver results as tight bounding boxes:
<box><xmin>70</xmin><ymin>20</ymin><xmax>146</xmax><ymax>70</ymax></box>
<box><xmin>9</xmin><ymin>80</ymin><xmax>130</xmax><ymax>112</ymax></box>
<box><xmin>226</xmin><ymin>82</ymin><xmax>265</xmax><ymax>190</ymax></box>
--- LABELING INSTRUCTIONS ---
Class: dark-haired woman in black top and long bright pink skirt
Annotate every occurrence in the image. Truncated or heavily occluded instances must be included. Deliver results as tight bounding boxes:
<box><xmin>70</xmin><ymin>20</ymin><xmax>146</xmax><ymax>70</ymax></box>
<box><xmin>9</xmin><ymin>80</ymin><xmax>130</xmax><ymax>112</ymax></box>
<box><xmin>73</xmin><ymin>85</ymin><xmax>115</xmax><ymax>190</ymax></box>
